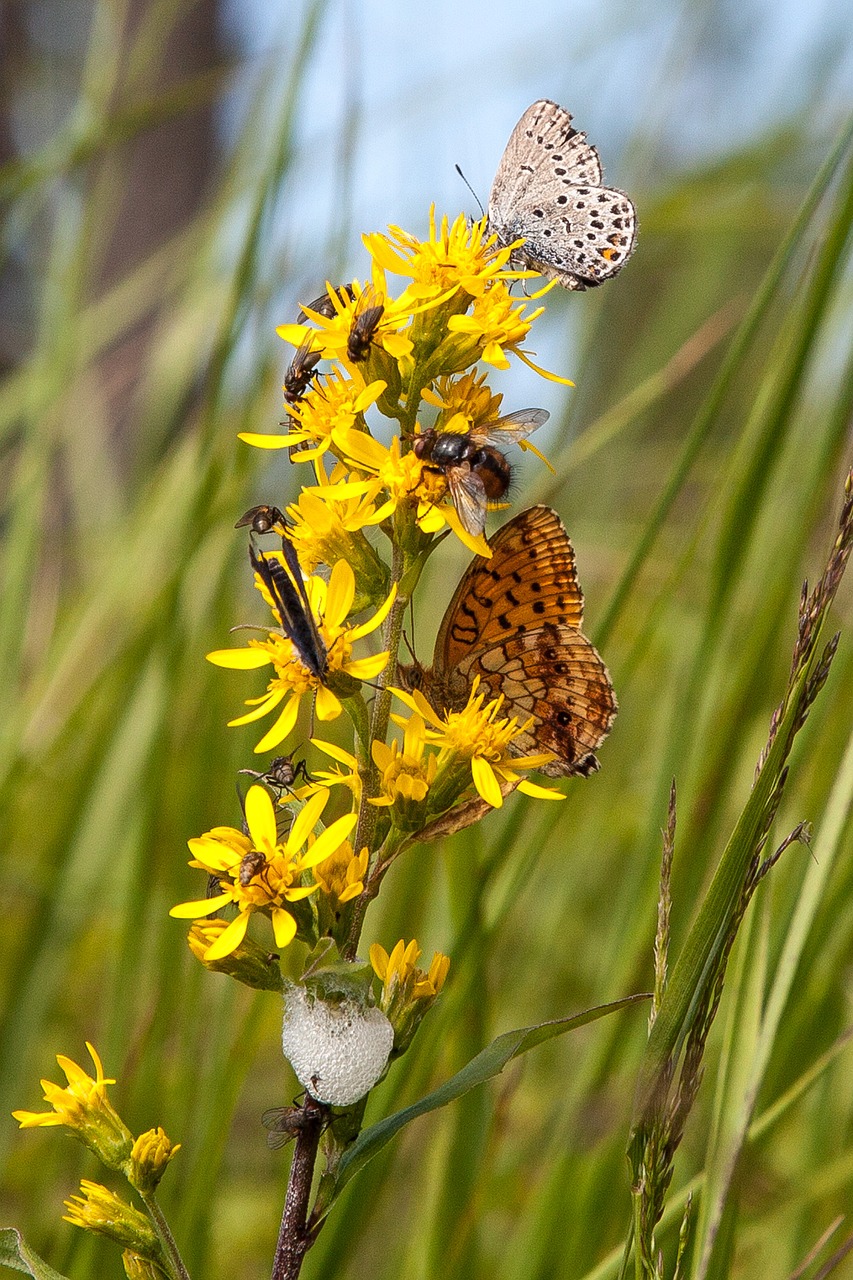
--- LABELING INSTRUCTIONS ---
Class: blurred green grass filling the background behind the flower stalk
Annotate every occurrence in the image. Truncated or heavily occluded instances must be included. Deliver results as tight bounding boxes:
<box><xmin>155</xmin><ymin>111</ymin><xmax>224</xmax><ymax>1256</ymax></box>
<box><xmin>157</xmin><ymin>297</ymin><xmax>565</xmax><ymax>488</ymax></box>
<box><xmin>0</xmin><ymin>5</ymin><xmax>853</xmax><ymax>1280</ymax></box>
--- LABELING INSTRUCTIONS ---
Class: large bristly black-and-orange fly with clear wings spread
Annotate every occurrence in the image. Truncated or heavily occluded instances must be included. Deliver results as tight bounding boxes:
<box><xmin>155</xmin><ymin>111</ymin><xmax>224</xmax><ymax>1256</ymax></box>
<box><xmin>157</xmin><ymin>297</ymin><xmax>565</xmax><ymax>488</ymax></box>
<box><xmin>412</xmin><ymin>408</ymin><xmax>549</xmax><ymax>538</ymax></box>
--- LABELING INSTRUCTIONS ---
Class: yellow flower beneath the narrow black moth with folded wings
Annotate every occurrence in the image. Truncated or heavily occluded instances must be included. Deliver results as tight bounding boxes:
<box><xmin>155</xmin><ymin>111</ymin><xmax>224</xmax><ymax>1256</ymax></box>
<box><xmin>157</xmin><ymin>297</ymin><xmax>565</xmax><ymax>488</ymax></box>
<box><xmin>207</xmin><ymin>556</ymin><xmax>397</xmax><ymax>751</ymax></box>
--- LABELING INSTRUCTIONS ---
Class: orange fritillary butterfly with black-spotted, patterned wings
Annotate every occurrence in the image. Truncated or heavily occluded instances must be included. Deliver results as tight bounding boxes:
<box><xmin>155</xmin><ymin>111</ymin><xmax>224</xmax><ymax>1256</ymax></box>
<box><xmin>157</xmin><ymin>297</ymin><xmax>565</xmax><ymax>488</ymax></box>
<box><xmin>402</xmin><ymin>507</ymin><xmax>616</xmax><ymax>777</ymax></box>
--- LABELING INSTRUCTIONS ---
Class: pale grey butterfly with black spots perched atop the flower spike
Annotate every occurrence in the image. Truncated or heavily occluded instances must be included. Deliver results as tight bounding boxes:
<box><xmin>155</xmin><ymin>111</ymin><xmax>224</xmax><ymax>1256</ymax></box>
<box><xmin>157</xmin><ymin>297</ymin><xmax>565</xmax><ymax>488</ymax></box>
<box><xmin>489</xmin><ymin>99</ymin><xmax>637</xmax><ymax>289</ymax></box>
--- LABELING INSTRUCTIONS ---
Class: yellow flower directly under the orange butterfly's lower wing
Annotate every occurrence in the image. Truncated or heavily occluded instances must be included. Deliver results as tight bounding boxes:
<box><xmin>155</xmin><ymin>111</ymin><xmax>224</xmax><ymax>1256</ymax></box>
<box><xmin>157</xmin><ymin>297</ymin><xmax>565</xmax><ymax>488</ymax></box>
<box><xmin>392</xmin><ymin>676</ymin><xmax>565</xmax><ymax>809</ymax></box>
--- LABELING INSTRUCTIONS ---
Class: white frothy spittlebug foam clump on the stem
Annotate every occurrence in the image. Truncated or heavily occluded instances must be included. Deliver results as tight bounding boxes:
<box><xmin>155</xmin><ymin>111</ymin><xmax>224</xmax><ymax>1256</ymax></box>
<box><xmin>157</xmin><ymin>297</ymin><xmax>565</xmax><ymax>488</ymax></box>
<box><xmin>282</xmin><ymin>987</ymin><xmax>394</xmax><ymax>1107</ymax></box>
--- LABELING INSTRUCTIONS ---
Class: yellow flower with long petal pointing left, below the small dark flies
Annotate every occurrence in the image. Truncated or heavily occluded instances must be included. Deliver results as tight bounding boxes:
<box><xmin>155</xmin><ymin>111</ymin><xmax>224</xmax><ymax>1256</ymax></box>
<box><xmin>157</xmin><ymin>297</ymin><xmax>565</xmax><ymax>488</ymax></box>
<box><xmin>238</xmin><ymin>369</ymin><xmax>387</xmax><ymax>462</ymax></box>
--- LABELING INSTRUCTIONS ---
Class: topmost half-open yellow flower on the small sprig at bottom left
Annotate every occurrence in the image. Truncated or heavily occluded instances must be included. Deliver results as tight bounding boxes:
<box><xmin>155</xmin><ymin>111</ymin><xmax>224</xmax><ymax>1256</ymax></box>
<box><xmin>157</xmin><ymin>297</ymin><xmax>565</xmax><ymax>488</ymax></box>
<box><xmin>12</xmin><ymin>1041</ymin><xmax>133</xmax><ymax>1169</ymax></box>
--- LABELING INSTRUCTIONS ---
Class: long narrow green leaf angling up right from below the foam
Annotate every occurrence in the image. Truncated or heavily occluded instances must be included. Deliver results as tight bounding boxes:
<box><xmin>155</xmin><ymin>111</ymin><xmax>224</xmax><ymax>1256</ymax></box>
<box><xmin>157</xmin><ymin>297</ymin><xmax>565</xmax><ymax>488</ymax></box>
<box><xmin>313</xmin><ymin>992</ymin><xmax>649</xmax><ymax>1216</ymax></box>
